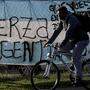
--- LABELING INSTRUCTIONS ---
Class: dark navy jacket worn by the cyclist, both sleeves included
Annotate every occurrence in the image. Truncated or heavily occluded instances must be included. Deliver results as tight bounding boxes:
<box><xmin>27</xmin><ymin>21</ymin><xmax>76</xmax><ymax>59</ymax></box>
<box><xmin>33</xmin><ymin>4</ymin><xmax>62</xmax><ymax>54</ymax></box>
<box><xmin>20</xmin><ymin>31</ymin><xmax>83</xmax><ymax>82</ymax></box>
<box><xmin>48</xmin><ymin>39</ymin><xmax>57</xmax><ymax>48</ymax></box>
<box><xmin>48</xmin><ymin>14</ymin><xmax>89</xmax><ymax>45</ymax></box>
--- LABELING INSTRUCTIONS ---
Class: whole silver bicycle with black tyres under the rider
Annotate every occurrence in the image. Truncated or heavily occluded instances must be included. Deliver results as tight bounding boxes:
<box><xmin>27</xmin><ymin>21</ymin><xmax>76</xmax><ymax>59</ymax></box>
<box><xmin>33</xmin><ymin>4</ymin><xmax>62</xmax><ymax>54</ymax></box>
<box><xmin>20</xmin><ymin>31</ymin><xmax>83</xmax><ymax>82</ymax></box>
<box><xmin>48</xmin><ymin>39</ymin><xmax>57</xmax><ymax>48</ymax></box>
<box><xmin>31</xmin><ymin>44</ymin><xmax>90</xmax><ymax>90</ymax></box>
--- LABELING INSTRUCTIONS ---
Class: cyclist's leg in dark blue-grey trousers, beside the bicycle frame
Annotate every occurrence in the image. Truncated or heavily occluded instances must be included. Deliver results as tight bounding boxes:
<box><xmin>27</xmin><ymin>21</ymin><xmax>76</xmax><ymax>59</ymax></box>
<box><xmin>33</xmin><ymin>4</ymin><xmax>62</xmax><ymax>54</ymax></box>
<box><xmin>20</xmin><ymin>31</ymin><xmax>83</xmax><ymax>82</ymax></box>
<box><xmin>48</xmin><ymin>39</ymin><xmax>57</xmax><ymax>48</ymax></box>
<box><xmin>73</xmin><ymin>40</ymin><xmax>89</xmax><ymax>78</ymax></box>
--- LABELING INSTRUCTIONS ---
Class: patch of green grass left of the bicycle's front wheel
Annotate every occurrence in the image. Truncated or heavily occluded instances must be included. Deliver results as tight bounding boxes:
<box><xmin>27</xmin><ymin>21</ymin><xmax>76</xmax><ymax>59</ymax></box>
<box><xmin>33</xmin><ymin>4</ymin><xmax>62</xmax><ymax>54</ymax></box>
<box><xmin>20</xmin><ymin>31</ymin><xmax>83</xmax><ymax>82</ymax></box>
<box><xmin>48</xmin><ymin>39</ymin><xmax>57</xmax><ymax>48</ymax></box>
<box><xmin>0</xmin><ymin>74</ymin><xmax>31</xmax><ymax>90</ymax></box>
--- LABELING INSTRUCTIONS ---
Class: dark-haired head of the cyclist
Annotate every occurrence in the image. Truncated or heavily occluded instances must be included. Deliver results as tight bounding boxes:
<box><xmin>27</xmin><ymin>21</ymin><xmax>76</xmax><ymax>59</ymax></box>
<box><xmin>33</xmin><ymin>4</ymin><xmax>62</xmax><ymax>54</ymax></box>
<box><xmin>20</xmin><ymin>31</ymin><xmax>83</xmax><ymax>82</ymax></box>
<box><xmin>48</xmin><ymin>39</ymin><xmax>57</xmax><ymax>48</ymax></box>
<box><xmin>58</xmin><ymin>6</ymin><xmax>68</xmax><ymax>20</ymax></box>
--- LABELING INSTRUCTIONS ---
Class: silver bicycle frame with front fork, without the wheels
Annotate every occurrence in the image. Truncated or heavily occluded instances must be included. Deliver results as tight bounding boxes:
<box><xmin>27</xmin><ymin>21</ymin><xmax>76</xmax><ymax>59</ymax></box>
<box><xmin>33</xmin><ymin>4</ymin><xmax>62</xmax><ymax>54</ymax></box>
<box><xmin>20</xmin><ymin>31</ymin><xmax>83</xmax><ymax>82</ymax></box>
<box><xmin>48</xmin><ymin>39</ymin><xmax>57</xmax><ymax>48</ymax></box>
<box><xmin>44</xmin><ymin>44</ymin><xmax>77</xmax><ymax>77</ymax></box>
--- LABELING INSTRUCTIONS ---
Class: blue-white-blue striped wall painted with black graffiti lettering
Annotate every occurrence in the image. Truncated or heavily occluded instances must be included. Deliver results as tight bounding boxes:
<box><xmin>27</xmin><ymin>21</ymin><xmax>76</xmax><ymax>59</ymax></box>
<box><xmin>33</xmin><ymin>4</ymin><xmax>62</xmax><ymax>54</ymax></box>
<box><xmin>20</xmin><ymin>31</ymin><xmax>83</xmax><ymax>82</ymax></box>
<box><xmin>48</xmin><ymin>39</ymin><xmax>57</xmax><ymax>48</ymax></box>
<box><xmin>0</xmin><ymin>0</ymin><xmax>89</xmax><ymax>64</ymax></box>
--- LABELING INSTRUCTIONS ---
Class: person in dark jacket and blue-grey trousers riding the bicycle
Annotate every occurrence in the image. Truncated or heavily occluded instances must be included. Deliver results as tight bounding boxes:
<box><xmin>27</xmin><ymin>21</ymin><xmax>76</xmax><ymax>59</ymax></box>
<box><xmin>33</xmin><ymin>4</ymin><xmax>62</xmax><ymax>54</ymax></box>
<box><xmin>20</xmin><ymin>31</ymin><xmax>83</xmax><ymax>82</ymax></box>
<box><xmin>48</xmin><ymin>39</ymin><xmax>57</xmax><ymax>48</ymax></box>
<box><xmin>45</xmin><ymin>6</ymin><xmax>89</xmax><ymax>85</ymax></box>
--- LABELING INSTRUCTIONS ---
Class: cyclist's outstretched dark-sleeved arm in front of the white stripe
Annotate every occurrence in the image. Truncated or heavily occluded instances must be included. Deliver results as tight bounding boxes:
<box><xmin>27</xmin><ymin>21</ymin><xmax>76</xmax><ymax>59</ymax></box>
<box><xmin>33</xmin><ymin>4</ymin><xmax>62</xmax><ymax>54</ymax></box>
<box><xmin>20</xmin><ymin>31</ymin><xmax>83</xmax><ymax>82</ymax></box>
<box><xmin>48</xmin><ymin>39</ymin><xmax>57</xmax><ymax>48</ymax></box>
<box><xmin>47</xmin><ymin>21</ymin><xmax>63</xmax><ymax>44</ymax></box>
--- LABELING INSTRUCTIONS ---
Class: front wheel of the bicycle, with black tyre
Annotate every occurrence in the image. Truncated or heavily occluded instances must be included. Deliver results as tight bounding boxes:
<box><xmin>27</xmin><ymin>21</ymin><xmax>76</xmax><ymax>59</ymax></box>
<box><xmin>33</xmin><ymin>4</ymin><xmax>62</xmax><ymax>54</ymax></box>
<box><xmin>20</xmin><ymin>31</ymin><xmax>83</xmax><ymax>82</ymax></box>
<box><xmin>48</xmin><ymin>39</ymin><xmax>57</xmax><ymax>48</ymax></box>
<box><xmin>31</xmin><ymin>60</ymin><xmax>60</xmax><ymax>90</ymax></box>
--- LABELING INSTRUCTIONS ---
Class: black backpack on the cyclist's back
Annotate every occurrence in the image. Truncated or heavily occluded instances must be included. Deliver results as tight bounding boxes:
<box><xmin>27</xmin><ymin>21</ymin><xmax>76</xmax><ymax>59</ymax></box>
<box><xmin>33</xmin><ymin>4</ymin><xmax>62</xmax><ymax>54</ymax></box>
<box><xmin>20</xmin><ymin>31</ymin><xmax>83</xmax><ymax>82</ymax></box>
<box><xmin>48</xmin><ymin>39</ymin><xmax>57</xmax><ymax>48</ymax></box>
<box><xmin>74</xmin><ymin>13</ymin><xmax>90</xmax><ymax>32</ymax></box>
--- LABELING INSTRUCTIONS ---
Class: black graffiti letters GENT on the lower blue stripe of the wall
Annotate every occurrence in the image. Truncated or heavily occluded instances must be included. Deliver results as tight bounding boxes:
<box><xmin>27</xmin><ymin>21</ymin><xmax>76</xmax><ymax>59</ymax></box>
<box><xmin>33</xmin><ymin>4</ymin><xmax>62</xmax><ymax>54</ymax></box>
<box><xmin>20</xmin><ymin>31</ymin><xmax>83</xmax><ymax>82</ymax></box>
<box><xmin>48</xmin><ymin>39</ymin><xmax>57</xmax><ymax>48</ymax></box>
<box><xmin>0</xmin><ymin>41</ymin><xmax>44</xmax><ymax>62</ymax></box>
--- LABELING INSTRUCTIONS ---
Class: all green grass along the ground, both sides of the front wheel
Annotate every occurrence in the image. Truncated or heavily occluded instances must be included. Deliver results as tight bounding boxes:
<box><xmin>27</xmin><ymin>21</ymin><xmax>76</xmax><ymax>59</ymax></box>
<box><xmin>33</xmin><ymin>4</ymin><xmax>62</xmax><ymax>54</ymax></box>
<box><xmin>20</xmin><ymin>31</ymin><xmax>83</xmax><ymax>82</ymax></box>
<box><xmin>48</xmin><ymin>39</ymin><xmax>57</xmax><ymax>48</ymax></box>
<box><xmin>0</xmin><ymin>72</ymin><xmax>90</xmax><ymax>90</ymax></box>
